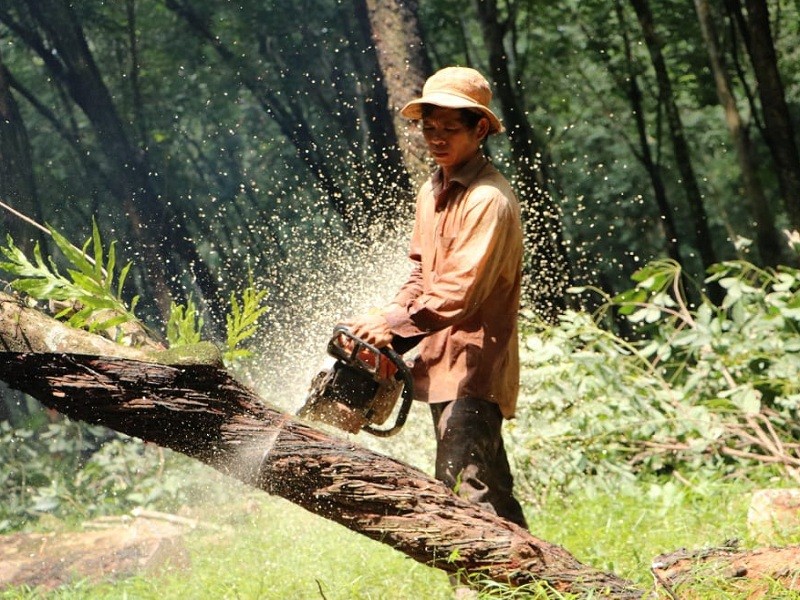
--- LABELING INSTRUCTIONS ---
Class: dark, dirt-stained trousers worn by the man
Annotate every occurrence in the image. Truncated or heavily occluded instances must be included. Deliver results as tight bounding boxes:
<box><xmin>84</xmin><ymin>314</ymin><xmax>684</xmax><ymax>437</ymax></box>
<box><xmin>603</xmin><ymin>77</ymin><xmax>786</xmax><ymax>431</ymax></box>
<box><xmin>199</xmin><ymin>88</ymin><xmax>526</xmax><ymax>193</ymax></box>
<box><xmin>430</xmin><ymin>398</ymin><xmax>528</xmax><ymax>529</ymax></box>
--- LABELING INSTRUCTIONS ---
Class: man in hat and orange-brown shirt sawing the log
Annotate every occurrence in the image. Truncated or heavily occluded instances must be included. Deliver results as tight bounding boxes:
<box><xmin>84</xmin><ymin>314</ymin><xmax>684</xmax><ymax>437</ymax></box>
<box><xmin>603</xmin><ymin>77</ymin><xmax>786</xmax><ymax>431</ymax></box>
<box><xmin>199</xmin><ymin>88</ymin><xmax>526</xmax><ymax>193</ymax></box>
<box><xmin>348</xmin><ymin>67</ymin><xmax>527</xmax><ymax>527</ymax></box>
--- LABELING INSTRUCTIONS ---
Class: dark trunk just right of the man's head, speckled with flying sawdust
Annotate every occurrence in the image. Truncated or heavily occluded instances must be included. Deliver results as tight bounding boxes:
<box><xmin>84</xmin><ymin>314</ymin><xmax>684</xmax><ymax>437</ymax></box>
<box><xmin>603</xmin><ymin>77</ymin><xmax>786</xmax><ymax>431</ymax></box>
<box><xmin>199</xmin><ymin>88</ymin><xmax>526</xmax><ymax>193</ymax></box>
<box><xmin>474</xmin><ymin>0</ymin><xmax>571</xmax><ymax>323</ymax></box>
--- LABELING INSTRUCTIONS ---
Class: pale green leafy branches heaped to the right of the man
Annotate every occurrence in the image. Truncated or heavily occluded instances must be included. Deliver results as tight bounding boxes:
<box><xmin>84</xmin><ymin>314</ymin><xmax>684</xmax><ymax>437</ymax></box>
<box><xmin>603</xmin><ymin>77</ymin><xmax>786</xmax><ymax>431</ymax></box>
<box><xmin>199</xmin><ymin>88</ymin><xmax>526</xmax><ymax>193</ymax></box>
<box><xmin>511</xmin><ymin>255</ymin><xmax>800</xmax><ymax>504</ymax></box>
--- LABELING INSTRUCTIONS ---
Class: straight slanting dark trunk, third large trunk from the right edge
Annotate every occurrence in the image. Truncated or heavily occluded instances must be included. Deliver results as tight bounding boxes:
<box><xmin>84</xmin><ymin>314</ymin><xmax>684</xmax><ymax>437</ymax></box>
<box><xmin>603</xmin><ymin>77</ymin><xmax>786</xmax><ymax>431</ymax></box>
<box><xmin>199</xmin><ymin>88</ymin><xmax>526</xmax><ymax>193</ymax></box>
<box><xmin>631</xmin><ymin>0</ymin><xmax>721</xmax><ymax>290</ymax></box>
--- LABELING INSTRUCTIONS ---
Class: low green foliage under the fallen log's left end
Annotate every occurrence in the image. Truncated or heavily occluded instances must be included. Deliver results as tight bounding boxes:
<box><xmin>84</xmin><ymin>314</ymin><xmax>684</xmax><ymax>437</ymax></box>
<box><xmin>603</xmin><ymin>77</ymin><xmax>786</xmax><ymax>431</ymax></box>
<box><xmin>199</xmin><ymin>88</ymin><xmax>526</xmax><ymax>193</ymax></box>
<box><xmin>0</xmin><ymin>420</ymin><xmax>206</xmax><ymax>531</ymax></box>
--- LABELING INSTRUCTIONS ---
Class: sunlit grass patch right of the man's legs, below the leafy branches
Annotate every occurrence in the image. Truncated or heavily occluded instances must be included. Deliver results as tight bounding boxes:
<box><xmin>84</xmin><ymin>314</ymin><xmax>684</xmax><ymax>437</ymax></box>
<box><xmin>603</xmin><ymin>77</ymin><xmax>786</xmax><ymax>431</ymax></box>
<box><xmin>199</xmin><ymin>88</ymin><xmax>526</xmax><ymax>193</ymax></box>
<box><xmin>529</xmin><ymin>480</ymin><xmax>752</xmax><ymax>585</ymax></box>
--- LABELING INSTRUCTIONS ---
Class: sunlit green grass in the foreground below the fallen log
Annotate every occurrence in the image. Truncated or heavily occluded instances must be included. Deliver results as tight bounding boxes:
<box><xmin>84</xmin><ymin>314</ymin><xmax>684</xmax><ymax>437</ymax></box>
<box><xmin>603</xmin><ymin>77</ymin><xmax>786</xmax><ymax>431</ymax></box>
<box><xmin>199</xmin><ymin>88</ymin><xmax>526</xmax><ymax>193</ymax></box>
<box><xmin>0</xmin><ymin>477</ymin><xmax>450</xmax><ymax>600</ymax></box>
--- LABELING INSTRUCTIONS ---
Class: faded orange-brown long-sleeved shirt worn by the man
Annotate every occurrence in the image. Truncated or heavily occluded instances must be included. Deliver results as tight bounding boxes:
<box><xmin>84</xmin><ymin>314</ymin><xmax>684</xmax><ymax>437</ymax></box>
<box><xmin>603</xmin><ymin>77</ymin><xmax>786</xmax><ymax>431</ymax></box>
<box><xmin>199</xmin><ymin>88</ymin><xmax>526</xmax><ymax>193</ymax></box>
<box><xmin>385</xmin><ymin>154</ymin><xmax>522</xmax><ymax>419</ymax></box>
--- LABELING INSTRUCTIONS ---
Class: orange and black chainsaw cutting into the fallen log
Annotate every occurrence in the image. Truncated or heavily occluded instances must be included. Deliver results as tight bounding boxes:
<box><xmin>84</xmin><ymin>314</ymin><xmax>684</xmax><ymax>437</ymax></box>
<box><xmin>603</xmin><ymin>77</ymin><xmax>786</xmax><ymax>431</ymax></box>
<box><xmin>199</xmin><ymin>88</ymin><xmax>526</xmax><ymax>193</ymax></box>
<box><xmin>297</xmin><ymin>325</ymin><xmax>413</xmax><ymax>437</ymax></box>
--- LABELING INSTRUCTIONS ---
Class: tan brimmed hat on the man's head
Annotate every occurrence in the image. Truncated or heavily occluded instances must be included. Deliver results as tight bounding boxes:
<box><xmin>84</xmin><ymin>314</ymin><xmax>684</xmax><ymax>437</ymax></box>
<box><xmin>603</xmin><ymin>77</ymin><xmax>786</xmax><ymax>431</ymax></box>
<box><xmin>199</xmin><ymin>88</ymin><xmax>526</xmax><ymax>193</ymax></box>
<box><xmin>400</xmin><ymin>67</ymin><xmax>504</xmax><ymax>133</ymax></box>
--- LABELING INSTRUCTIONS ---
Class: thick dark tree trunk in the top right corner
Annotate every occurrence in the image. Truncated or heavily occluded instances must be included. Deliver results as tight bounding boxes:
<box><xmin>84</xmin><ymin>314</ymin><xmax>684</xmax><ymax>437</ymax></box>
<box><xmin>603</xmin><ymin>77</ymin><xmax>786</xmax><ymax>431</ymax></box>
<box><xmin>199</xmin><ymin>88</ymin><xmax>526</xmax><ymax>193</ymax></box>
<box><xmin>744</xmin><ymin>0</ymin><xmax>800</xmax><ymax>230</ymax></box>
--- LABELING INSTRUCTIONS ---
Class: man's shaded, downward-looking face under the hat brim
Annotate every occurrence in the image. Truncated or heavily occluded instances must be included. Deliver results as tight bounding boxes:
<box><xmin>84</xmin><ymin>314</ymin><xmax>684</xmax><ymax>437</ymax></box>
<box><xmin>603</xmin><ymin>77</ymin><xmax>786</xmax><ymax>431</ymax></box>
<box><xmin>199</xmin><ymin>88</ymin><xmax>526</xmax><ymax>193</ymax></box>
<box><xmin>422</xmin><ymin>106</ymin><xmax>489</xmax><ymax>173</ymax></box>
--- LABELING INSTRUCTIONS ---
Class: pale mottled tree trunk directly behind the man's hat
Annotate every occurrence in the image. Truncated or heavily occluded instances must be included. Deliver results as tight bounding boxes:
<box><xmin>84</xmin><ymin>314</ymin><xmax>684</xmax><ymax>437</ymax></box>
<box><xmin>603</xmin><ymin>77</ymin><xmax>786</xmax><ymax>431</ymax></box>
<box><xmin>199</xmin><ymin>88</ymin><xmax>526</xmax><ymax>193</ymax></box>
<box><xmin>354</xmin><ymin>0</ymin><xmax>432</xmax><ymax>191</ymax></box>
